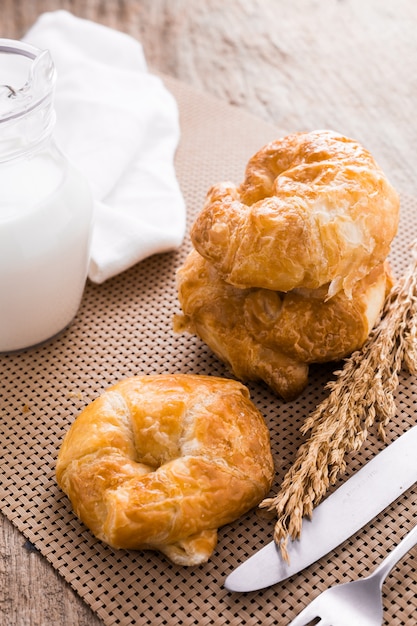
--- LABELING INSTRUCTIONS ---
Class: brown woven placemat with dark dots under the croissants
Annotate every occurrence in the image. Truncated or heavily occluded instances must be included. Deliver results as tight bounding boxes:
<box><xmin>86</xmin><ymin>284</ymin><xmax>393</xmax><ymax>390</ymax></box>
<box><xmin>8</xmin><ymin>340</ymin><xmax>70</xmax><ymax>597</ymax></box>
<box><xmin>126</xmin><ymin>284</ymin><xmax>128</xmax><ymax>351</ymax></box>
<box><xmin>0</xmin><ymin>79</ymin><xmax>417</xmax><ymax>626</ymax></box>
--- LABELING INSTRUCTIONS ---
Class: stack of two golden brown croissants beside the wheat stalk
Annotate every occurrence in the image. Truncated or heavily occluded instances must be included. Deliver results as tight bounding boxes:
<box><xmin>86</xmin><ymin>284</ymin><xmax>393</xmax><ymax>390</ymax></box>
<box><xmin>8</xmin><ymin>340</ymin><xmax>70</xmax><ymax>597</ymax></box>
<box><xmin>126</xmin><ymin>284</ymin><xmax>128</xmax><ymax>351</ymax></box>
<box><xmin>175</xmin><ymin>130</ymin><xmax>399</xmax><ymax>400</ymax></box>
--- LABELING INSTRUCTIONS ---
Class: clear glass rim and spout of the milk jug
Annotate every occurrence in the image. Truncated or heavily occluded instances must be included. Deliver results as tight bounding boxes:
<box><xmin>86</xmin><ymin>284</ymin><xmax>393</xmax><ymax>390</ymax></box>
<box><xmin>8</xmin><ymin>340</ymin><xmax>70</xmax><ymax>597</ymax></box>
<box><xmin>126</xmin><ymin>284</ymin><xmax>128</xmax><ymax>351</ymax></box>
<box><xmin>0</xmin><ymin>38</ymin><xmax>56</xmax><ymax>123</ymax></box>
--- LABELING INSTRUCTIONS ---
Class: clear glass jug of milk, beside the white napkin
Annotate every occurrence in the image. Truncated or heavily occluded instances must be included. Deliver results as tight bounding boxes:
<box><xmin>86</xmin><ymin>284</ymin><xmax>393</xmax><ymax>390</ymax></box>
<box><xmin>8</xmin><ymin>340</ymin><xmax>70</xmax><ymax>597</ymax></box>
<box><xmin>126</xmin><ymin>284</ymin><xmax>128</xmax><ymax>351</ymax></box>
<box><xmin>0</xmin><ymin>39</ymin><xmax>93</xmax><ymax>352</ymax></box>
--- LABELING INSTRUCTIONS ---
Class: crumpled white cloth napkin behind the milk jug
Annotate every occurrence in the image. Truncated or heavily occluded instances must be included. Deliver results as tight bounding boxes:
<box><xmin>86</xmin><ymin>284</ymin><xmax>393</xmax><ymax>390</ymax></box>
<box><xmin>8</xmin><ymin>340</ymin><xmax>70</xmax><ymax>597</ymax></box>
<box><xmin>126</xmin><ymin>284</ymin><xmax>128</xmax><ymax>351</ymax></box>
<box><xmin>24</xmin><ymin>11</ymin><xmax>185</xmax><ymax>283</ymax></box>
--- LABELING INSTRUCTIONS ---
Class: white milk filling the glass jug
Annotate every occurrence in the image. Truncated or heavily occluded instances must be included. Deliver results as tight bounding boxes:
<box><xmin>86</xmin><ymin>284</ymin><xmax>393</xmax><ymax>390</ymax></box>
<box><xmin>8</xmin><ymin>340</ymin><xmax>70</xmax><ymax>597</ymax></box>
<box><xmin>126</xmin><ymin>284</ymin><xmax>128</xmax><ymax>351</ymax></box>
<box><xmin>0</xmin><ymin>149</ymin><xmax>92</xmax><ymax>352</ymax></box>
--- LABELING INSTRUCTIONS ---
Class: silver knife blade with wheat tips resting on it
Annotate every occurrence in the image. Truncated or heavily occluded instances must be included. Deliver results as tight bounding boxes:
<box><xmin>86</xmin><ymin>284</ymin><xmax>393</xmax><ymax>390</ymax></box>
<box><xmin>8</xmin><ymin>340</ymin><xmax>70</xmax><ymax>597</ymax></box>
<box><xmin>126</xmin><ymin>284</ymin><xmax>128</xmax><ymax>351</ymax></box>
<box><xmin>224</xmin><ymin>426</ymin><xmax>417</xmax><ymax>592</ymax></box>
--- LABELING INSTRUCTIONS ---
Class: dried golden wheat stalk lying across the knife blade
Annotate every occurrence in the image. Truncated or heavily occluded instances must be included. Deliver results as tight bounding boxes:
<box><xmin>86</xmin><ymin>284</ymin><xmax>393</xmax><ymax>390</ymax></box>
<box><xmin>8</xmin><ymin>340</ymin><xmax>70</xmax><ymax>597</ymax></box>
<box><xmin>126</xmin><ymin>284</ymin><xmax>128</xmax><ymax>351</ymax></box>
<box><xmin>260</xmin><ymin>241</ymin><xmax>417</xmax><ymax>561</ymax></box>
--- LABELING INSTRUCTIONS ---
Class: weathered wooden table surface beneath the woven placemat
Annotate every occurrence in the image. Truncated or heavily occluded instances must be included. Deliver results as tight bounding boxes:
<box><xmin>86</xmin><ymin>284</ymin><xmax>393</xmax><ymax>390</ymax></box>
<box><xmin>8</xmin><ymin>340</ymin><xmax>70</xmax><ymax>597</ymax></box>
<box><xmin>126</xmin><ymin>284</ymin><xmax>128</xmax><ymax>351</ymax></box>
<box><xmin>0</xmin><ymin>0</ymin><xmax>417</xmax><ymax>626</ymax></box>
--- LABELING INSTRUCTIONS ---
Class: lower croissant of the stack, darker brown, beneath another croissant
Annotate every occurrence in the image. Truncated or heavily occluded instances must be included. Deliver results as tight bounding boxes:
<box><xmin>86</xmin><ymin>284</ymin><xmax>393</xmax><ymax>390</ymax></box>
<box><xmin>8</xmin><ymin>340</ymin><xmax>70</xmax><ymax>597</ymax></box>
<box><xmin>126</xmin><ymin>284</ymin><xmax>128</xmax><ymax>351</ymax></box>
<box><xmin>174</xmin><ymin>250</ymin><xmax>392</xmax><ymax>400</ymax></box>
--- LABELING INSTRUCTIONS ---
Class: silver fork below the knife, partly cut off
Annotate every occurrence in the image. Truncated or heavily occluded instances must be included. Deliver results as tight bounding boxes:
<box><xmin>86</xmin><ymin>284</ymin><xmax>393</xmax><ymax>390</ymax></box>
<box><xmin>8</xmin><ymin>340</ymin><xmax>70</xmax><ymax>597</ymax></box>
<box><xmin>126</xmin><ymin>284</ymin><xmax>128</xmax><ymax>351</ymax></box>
<box><xmin>288</xmin><ymin>526</ymin><xmax>417</xmax><ymax>626</ymax></box>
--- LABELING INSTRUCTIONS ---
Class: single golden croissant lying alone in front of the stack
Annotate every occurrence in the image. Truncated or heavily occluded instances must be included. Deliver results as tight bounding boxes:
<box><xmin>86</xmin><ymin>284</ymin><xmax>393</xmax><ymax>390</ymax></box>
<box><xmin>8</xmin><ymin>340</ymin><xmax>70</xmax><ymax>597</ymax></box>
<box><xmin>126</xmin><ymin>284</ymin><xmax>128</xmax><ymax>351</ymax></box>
<box><xmin>56</xmin><ymin>374</ymin><xmax>273</xmax><ymax>565</ymax></box>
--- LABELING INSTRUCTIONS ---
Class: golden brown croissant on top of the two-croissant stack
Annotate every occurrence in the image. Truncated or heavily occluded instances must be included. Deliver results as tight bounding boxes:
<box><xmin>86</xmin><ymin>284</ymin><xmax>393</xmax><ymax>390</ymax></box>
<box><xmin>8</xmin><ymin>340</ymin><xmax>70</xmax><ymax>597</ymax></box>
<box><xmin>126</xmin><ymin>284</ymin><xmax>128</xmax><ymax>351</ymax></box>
<box><xmin>191</xmin><ymin>131</ymin><xmax>399</xmax><ymax>297</ymax></box>
